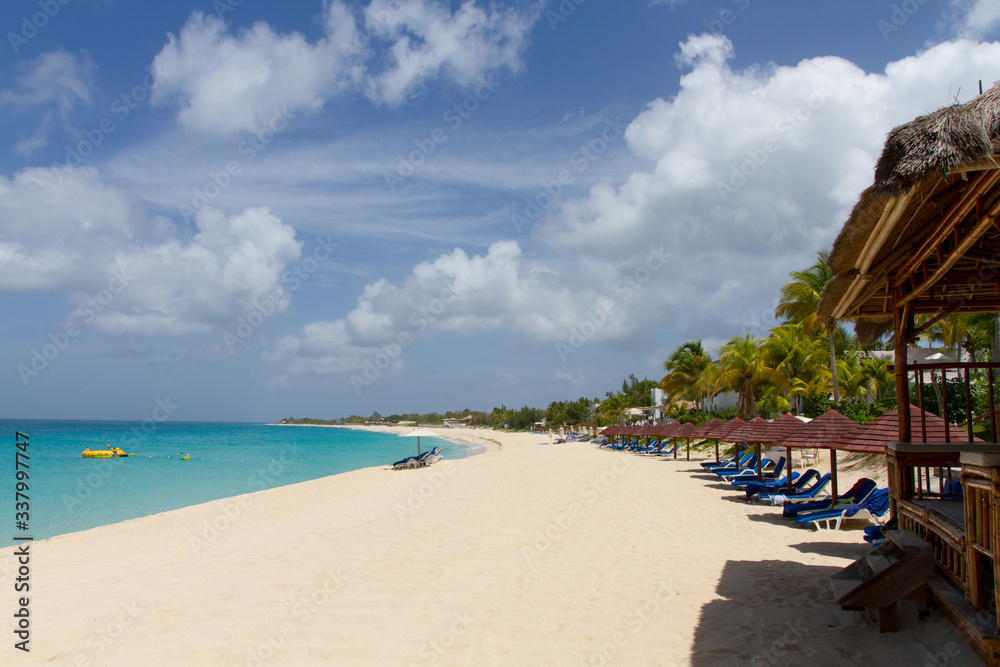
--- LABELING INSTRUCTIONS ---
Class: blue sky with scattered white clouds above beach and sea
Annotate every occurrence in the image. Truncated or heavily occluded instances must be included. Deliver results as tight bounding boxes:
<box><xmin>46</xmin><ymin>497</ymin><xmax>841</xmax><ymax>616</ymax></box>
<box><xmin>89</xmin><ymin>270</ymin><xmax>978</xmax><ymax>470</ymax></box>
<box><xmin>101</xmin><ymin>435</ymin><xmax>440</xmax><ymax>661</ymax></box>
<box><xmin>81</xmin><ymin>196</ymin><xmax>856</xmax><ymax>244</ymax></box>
<box><xmin>0</xmin><ymin>0</ymin><xmax>1000</xmax><ymax>421</ymax></box>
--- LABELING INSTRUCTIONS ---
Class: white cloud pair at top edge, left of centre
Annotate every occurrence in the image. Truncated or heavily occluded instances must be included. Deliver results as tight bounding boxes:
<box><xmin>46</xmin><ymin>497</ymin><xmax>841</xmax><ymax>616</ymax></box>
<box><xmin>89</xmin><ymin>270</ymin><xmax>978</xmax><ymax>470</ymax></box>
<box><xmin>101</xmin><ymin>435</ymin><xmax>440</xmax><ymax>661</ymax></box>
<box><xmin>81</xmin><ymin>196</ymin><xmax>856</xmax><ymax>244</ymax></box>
<box><xmin>152</xmin><ymin>0</ymin><xmax>537</xmax><ymax>134</ymax></box>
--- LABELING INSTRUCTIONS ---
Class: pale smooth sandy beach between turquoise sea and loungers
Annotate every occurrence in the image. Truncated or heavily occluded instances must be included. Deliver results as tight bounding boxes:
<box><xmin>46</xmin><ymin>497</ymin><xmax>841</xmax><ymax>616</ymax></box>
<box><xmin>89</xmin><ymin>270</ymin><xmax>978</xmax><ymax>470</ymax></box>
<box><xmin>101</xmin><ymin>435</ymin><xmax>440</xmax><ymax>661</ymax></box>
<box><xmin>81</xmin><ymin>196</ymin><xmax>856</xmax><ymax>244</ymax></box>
<box><xmin>0</xmin><ymin>429</ymin><xmax>978</xmax><ymax>665</ymax></box>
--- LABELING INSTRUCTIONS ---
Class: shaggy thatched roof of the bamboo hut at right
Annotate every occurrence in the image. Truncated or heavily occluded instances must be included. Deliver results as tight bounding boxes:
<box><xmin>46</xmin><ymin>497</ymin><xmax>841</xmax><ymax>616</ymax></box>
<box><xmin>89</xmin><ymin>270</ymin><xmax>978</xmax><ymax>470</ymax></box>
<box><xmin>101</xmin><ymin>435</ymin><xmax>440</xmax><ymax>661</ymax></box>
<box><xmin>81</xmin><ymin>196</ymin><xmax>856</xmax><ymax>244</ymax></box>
<box><xmin>819</xmin><ymin>79</ymin><xmax>1000</xmax><ymax>328</ymax></box>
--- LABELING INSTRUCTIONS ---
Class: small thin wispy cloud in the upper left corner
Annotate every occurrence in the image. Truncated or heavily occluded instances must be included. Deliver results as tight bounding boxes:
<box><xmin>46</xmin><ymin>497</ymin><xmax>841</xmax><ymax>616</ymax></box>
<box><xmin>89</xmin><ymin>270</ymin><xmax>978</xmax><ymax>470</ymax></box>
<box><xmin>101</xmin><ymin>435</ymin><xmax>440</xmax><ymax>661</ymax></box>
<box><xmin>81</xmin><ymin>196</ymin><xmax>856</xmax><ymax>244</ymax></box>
<box><xmin>0</xmin><ymin>50</ymin><xmax>97</xmax><ymax>155</ymax></box>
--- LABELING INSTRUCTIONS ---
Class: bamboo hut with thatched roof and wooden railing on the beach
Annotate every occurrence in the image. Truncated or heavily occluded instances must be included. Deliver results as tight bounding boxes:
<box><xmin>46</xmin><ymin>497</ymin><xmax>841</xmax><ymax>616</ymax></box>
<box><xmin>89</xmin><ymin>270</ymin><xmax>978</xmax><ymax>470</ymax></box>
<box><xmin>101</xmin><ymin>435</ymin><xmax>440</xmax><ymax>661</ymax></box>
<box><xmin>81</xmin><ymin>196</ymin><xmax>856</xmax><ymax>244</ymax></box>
<box><xmin>819</xmin><ymin>81</ymin><xmax>1000</xmax><ymax>664</ymax></box>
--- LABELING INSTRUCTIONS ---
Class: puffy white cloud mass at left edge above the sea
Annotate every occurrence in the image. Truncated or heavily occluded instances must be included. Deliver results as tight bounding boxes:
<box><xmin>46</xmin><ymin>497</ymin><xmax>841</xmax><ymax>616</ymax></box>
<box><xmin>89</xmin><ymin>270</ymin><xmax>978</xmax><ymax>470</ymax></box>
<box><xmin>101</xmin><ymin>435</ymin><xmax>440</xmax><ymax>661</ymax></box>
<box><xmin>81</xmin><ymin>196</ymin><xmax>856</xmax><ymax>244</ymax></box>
<box><xmin>0</xmin><ymin>167</ymin><xmax>301</xmax><ymax>336</ymax></box>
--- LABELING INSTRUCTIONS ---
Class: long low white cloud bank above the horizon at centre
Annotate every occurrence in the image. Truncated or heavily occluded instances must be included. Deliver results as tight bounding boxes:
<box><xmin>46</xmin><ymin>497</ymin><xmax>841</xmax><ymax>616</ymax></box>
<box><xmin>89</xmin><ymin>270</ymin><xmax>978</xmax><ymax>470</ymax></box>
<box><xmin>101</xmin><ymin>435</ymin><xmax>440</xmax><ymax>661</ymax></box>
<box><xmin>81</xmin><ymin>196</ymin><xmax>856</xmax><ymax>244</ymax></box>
<box><xmin>271</xmin><ymin>241</ymin><xmax>665</xmax><ymax>374</ymax></box>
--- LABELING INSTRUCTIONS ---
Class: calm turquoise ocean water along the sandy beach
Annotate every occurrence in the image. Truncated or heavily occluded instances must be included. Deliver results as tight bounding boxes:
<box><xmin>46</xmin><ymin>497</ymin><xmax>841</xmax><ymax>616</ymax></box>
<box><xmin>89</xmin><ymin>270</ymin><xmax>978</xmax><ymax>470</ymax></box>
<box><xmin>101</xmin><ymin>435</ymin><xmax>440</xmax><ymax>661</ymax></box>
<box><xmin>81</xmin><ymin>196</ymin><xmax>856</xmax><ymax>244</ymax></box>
<box><xmin>0</xmin><ymin>420</ymin><xmax>481</xmax><ymax>546</ymax></box>
